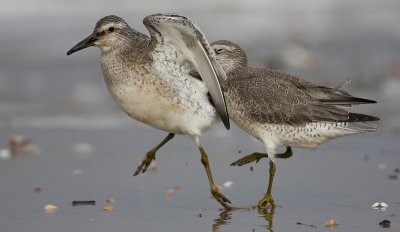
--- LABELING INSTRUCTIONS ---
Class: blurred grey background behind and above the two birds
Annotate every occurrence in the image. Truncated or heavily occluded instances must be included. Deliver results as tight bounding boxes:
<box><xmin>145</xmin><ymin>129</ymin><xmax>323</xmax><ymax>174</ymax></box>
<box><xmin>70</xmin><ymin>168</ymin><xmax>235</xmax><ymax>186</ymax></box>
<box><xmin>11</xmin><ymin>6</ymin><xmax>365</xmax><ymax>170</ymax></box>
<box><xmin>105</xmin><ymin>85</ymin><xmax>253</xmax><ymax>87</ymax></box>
<box><xmin>0</xmin><ymin>0</ymin><xmax>400</xmax><ymax>133</ymax></box>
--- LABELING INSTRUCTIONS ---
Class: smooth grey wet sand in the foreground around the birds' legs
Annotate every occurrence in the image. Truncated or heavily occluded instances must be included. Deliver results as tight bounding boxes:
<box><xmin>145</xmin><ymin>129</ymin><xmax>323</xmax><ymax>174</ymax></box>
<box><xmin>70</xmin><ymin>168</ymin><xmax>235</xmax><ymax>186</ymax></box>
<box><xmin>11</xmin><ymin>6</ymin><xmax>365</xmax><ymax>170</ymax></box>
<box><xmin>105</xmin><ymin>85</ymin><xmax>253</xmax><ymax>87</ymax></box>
<box><xmin>0</xmin><ymin>123</ymin><xmax>400</xmax><ymax>232</ymax></box>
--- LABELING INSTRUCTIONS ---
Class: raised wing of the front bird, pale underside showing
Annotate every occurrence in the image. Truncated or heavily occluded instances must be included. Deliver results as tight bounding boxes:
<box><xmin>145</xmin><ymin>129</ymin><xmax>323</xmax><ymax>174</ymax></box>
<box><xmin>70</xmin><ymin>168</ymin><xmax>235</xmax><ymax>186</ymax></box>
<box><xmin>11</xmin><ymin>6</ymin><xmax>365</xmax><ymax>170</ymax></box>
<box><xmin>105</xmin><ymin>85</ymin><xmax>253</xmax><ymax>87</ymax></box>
<box><xmin>143</xmin><ymin>14</ymin><xmax>230</xmax><ymax>129</ymax></box>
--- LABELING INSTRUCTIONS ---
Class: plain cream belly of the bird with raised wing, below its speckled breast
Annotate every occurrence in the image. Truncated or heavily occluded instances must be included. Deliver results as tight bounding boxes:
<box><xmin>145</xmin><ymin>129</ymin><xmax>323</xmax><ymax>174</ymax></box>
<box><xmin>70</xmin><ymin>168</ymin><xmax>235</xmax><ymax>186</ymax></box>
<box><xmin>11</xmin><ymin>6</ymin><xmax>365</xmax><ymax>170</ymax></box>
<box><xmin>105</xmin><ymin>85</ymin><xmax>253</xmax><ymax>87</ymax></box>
<box><xmin>110</xmin><ymin>85</ymin><xmax>216</xmax><ymax>135</ymax></box>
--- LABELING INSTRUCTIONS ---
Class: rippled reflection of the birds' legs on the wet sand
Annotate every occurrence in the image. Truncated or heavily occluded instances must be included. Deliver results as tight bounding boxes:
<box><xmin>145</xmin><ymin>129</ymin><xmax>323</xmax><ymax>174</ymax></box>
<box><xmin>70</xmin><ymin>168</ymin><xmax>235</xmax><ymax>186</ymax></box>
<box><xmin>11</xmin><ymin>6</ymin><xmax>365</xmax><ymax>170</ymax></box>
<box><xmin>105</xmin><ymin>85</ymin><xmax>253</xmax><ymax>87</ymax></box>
<box><xmin>211</xmin><ymin>206</ymin><xmax>276</xmax><ymax>232</ymax></box>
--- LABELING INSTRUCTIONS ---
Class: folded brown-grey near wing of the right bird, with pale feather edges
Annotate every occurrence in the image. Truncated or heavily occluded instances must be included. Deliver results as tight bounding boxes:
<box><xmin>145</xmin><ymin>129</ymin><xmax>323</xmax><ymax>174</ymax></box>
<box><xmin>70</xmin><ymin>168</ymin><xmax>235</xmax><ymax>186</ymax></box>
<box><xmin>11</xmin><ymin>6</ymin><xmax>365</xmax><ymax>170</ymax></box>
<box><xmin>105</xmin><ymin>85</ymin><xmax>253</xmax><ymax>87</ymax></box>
<box><xmin>226</xmin><ymin>76</ymin><xmax>349</xmax><ymax>126</ymax></box>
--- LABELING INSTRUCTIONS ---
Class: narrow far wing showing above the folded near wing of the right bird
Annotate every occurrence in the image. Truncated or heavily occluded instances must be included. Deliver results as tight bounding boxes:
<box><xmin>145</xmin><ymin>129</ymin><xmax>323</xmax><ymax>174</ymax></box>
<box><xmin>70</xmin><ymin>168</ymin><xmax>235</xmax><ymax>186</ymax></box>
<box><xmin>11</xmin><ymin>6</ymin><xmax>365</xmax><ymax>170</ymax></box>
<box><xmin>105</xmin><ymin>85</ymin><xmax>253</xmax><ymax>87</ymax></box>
<box><xmin>260</xmin><ymin>69</ymin><xmax>376</xmax><ymax>106</ymax></box>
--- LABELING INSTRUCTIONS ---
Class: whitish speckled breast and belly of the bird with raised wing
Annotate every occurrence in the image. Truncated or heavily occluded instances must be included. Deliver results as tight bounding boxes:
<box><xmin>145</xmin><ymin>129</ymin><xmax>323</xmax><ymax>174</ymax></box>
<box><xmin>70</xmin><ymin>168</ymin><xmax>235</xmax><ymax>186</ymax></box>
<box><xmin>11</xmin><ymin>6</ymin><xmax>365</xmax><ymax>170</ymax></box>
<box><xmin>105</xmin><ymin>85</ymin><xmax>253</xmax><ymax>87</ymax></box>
<box><xmin>102</xmin><ymin>49</ymin><xmax>216</xmax><ymax>135</ymax></box>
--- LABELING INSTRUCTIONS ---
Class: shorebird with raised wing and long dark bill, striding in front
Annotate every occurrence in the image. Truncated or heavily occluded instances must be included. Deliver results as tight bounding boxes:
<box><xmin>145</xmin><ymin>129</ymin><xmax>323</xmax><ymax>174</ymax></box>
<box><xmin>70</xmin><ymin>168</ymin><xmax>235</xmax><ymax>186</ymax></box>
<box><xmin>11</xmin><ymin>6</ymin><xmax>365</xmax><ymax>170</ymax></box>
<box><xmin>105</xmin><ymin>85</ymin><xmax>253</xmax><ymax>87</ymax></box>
<box><xmin>67</xmin><ymin>14</ymin><xmax>231</xmax><ymax>208</ymax></box>
